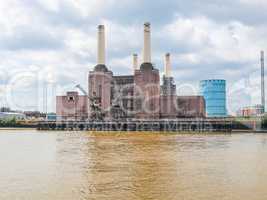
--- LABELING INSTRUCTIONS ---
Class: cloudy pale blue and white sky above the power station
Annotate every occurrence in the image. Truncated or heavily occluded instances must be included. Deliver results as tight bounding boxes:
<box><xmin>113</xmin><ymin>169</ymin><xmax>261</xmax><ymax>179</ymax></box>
<box><xmin>0</xmin><ymin>0</ymin><xmax>267</xmax><ymax>114</ymax></box>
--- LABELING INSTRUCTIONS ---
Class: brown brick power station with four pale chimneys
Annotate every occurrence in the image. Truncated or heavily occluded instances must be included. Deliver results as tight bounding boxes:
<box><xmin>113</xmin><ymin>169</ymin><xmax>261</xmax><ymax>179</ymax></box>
<box><xmin>57</xmin><ymin>23</ymin><xmax>206</xmax><ymax>120</ymax></box>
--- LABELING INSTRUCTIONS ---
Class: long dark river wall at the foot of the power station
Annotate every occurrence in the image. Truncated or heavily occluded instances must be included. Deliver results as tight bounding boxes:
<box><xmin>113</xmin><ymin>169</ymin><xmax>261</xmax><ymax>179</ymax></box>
<box><xmin>37</xmin><ymin>119</ymin><xmax>232</xmax><ymax>132</ymax></box>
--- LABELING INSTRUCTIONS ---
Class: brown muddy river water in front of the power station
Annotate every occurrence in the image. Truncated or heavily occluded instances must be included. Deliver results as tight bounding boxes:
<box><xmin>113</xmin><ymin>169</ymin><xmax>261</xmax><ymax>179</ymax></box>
<box><xmin>0</xmin><ymin>130</ymin><xmax>267</xmax><ymax>200</ymax></box>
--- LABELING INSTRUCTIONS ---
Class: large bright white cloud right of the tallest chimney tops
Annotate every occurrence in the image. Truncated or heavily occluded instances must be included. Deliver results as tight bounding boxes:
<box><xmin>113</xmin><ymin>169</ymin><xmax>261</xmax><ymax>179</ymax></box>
<box><xmin>161</xmin><ymin>16</ymin><xmax>267</xmax><ymax>63</ymax></box>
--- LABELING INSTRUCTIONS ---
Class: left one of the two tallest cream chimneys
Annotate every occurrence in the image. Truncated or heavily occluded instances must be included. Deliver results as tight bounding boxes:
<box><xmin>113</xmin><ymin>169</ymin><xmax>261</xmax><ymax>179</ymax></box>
<box><xmin>97</xmin><ymin>25</ymin><xmax>106</xmax><ymax>65</ymax></box>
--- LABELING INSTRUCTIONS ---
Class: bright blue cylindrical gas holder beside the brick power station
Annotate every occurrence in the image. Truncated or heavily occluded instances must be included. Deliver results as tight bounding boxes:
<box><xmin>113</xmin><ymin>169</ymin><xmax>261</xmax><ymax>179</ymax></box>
<box><xmin>200</xmin><ymin>79</ymin><xmax>227</xmax><ymax>117</ymax></box>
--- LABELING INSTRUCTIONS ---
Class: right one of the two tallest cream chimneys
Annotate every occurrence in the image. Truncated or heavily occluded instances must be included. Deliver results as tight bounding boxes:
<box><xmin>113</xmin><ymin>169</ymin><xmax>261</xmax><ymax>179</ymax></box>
<box><xmin>143</xmin><ymin>22</ymin><xmax>151</xmax><ymax>63</ymax></box>
